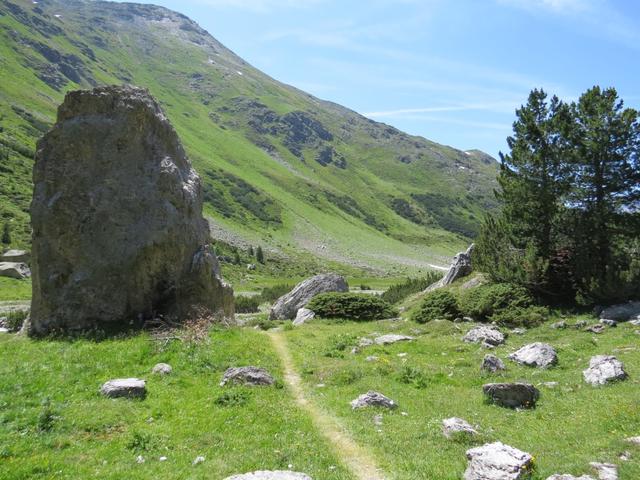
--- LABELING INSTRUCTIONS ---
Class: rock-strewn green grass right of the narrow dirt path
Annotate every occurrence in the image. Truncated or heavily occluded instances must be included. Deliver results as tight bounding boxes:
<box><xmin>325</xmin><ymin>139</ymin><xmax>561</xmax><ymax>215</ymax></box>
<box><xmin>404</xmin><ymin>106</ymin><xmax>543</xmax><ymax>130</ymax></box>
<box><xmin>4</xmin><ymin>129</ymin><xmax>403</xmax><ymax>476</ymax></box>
<box><xmin>283</xmin><ymin>321</ymin><xmax>640</xmax><ymax>480</ymax></box>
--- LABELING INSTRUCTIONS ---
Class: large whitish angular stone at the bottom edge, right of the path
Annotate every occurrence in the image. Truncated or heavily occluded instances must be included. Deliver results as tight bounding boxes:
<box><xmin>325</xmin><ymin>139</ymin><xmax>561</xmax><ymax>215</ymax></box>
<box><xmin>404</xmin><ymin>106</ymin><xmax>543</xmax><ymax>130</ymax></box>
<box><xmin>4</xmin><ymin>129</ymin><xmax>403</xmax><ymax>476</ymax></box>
<box><xmin>464</xmin><ymin>442</ymin><xmax>533</xmax><ymax>480</ymax></box>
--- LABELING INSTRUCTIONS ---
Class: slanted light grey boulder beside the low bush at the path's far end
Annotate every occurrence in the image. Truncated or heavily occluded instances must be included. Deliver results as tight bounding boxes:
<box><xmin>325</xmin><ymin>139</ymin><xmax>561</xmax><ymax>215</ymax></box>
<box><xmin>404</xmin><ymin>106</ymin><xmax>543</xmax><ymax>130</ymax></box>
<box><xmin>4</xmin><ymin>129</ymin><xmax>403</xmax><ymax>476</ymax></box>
<box><xmin>269</xmin><ymin>273</ymin><xmax>349</xmax><ymax>320</ymax></box>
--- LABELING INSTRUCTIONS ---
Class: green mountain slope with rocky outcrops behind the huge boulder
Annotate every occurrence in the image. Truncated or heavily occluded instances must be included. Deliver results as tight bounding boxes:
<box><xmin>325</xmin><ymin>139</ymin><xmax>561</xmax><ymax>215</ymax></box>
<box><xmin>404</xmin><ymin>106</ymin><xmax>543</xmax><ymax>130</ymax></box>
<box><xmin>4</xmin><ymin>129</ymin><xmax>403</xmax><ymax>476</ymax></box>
<box><xmin>0</xmin><ymin>0</ymin><xmax>496</xmax><ymax>269</ymax></box>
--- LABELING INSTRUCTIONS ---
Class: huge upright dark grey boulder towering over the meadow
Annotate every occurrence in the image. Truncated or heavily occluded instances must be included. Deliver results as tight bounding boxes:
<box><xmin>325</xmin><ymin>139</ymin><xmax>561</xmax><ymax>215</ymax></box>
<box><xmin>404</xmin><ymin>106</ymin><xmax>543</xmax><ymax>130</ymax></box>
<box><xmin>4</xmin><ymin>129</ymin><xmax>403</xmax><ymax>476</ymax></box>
<box><xmin>30</xmin><ymin>86</ymin><xmax>233</xmax><ymax>335</ymax></box>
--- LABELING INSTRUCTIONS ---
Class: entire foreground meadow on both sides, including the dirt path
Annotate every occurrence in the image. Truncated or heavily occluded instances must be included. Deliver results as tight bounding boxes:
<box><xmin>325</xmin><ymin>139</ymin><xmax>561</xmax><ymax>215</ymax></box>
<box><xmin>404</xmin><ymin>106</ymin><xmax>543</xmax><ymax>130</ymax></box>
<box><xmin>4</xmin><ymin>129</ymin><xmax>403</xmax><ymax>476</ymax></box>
<box><xmin>0</xmin><ymin>321</ymin><xmax>640</xmax><ymax>480</ymax></box>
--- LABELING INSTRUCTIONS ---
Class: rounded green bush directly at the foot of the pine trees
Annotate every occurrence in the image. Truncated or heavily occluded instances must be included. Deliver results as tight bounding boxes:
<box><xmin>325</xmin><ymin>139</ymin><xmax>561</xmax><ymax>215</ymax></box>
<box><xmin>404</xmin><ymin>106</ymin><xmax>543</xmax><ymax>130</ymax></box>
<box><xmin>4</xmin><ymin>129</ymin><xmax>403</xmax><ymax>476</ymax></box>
<box><xmin>460</xmin><ymin>283</ymin><xmax>535</xmax><ymax>322</ymax></box>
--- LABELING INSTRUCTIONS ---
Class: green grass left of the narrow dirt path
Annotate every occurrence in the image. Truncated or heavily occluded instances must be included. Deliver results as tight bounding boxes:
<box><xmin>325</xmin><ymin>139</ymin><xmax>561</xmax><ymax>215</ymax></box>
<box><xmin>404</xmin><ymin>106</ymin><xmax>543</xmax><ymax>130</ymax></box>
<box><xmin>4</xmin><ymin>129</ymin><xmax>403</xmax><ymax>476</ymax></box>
<box><xmin>0</xmin><ymin>329</ymin><xmax>351</xmax><ymax>480</ymax></box>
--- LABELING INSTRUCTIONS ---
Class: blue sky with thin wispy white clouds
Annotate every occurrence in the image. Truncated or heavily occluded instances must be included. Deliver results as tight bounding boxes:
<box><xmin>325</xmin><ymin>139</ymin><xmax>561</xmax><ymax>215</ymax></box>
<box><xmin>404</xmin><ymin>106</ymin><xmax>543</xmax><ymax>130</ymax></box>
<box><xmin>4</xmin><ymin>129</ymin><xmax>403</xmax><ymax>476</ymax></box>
<box><xmin>130</xmin><ymin>0</ymin><xmax>640</xmax><ymax>156</ymax></box>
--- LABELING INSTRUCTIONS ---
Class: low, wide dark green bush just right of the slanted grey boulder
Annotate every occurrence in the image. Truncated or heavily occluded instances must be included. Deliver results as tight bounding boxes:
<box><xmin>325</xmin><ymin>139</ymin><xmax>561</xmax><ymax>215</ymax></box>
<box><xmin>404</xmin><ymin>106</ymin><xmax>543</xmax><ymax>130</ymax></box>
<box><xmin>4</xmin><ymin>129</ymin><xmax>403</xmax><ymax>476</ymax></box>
<box><xmin>307</xmin><ymin>292</ymin><xmax>397</xmax><ymax>320</ymax></box>
